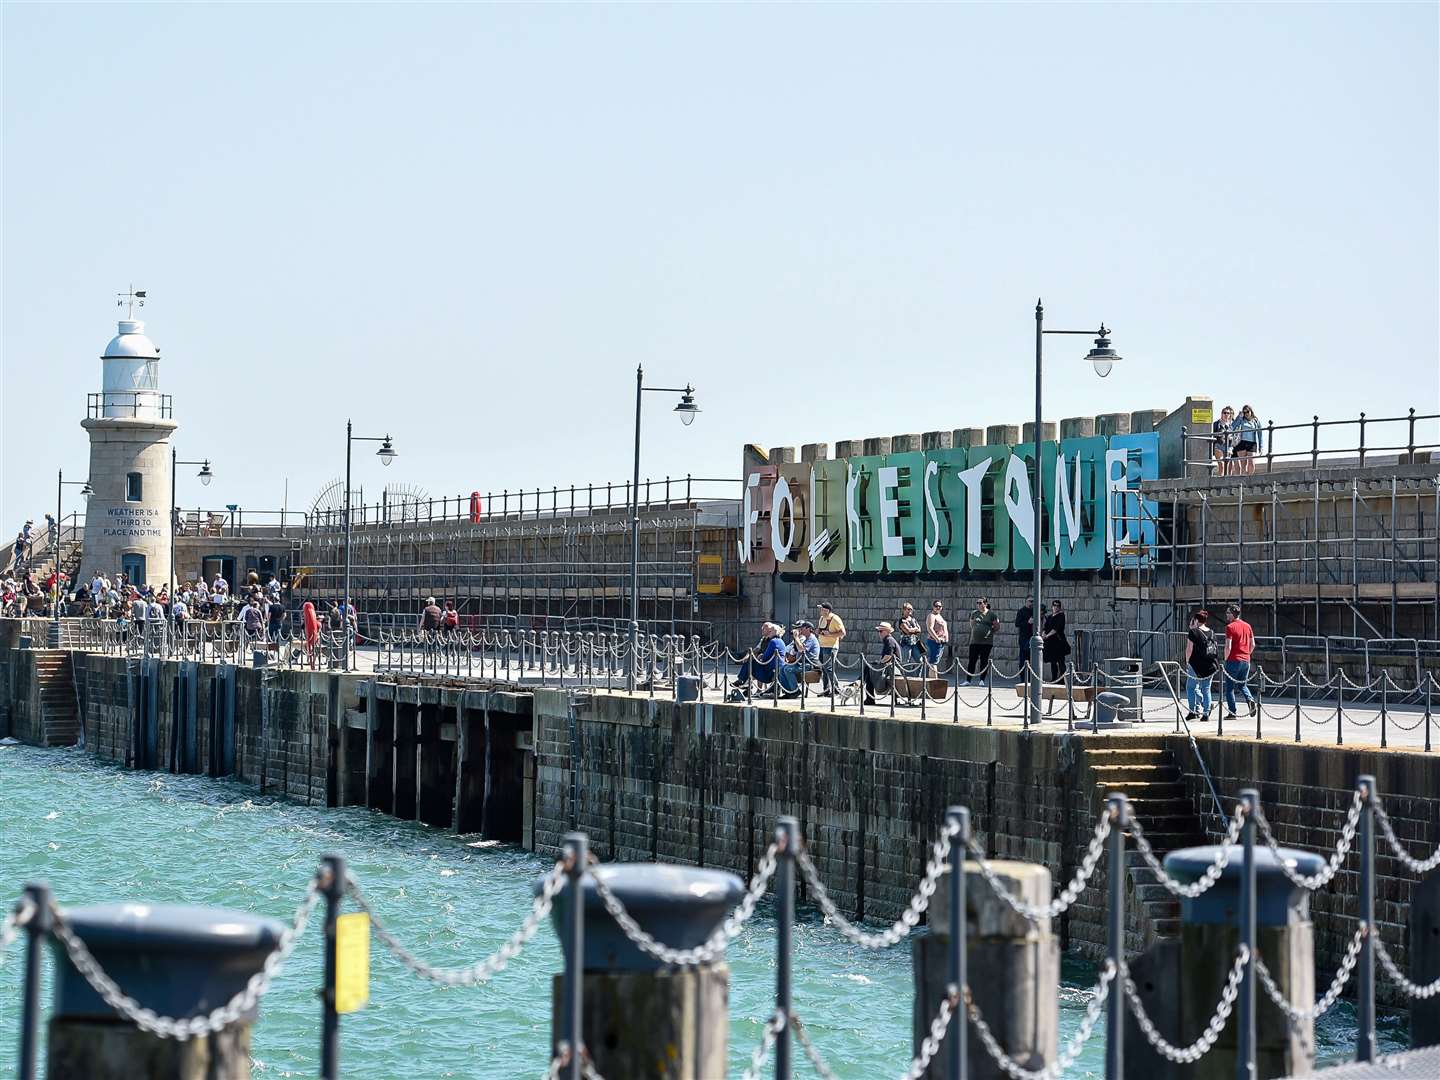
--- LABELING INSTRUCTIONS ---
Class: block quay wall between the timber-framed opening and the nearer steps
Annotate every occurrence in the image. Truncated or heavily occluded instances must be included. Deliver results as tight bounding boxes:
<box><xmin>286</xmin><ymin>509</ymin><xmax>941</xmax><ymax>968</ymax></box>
<box><xmin>534</xmin><ymin>690</ymin><xmax>1162</xmax><ymax>955</ymax></box>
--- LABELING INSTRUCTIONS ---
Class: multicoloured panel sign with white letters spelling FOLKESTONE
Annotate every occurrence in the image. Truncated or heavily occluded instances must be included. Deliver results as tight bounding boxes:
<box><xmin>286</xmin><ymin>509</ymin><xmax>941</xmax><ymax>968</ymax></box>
<box><xmin>740</xmin><ymin>432</ymin><xmax>1159</xmax><ymax>575</ymax></box>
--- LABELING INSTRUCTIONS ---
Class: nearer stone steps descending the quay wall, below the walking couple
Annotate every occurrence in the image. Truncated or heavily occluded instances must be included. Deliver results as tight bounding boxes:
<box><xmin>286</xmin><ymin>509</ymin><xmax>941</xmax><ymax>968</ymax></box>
<box><xmin>1086</xmin><ymin>749</ymin><xmax>1208</xmax><ymax>946</ymax></box>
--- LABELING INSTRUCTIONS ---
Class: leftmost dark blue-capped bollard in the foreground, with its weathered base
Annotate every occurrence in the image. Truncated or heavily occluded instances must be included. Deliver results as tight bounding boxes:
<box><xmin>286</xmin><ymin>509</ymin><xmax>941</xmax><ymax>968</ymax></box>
<box><xmin>46</xmin><ymin>903</ymin><xmax>284</xmax><ymax>1080</ymax></box>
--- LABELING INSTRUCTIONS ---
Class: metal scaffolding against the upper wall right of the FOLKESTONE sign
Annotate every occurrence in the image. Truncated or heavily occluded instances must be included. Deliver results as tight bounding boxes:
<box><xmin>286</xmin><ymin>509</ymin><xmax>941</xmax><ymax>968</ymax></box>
<box><xmin>1112</xmin><ymin>465</ymin><xmax>1440</xmax><ymax>639</ymax></box>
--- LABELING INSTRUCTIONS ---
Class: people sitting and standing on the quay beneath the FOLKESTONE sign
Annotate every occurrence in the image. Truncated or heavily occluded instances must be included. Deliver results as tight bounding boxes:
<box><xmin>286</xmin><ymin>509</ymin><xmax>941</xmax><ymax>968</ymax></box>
<box><xmin>732</xmin><ymin>596</ymin><xmax>1070</xmax><ymax>704</ymax></box>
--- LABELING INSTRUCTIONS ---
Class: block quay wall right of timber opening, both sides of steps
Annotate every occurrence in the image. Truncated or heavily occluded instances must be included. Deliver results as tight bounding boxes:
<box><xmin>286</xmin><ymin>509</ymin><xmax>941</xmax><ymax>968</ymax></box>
<box><xmin>534</xmin><ymin>690</ymin><xmax>1440</xmax><ymax>1004</ymax></box>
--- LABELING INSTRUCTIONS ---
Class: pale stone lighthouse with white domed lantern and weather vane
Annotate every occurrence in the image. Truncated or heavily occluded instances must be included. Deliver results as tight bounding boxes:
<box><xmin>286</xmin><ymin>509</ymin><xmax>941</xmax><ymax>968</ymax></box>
<box><xmin>81</xmin><ymin>289</ymin><xmax>176</xmax><ymax>586</ymax></box>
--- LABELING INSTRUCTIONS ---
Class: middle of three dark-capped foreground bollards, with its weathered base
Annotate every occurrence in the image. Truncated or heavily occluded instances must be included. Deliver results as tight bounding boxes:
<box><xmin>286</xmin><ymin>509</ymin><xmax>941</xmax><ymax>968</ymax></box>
<box><xmin>537</xmin><ymin>863</ymin><xmax>744</xmax><ymax>1080</ymax></box>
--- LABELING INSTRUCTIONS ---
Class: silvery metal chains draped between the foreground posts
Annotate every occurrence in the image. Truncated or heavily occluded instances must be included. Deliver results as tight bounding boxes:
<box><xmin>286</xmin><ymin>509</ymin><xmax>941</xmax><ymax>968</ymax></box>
<box><xmin>0</xmin><ymin>783</ymin><xmax>1440</xmax><ymax>1080</ymax></box>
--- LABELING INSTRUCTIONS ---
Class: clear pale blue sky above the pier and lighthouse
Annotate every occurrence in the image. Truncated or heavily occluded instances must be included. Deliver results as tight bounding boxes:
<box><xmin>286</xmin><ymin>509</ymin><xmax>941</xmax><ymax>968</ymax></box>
<box><xmin>0</xmin><ymin>3</ymin><xmax>1440</xmax><ymax>530</ymax></box>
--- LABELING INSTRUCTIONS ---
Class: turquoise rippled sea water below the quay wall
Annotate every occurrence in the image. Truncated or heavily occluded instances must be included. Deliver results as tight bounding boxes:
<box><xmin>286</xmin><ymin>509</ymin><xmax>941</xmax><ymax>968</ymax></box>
<box><xmin>0</xmin><ymin>746</ymin><xmax>1404</xmax><ymax>1080</ymax></box>
